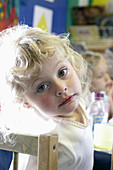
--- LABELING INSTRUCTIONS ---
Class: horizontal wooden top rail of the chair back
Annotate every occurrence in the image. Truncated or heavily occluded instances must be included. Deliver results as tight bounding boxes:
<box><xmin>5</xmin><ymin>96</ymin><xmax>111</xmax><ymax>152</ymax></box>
<box><xmin>0</xmin><ymin>133</ymin><xmax>38</xmax><ymax>156</ymax></box>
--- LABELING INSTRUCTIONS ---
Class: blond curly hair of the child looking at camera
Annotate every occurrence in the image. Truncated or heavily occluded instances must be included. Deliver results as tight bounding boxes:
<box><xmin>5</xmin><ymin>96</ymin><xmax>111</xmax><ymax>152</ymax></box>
<box><xmin>0</xmin><ymin>25</ymin><xmax>90</xmax><ymax>101</ymax></box>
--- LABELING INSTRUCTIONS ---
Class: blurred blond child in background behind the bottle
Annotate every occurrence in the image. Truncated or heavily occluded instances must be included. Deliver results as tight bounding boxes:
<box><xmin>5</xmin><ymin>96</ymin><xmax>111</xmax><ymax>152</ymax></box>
<box><xmin>82</xmin><ymin>51</ymin><xmax>113</xmax><ymax>119</ymax></box>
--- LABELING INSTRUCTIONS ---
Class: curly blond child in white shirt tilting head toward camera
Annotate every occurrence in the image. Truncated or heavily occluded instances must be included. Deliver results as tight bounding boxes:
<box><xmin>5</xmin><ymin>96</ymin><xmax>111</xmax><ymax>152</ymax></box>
<box><xmin>1</xmin><ymin>25</ymin><xmax>93</xmax><ymax>170</ymax></box>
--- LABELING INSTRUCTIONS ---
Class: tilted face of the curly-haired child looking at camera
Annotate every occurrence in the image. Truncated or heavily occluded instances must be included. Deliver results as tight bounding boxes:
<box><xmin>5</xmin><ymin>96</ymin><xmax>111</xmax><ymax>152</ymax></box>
<box><xmin>25</xmin><ymin>55</ymin><xmax>82</xmax><ymax>116</ymax></box>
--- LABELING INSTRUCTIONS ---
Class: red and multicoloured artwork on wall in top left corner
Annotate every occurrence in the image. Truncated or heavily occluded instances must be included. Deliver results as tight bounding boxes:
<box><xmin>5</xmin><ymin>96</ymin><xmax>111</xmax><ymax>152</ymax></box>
<box><xmin>0</xmin><ymin>0</ymin><xmax>19</xmax><ymax>31</ymax></box>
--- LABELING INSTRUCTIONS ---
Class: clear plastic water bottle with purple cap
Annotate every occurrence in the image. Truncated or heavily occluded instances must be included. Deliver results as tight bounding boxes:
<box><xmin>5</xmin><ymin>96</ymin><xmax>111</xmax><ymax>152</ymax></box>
<box><xmin>87</xmin><ymin>93</ymin><xmax>108</xmax><ymax>131</ymax></box>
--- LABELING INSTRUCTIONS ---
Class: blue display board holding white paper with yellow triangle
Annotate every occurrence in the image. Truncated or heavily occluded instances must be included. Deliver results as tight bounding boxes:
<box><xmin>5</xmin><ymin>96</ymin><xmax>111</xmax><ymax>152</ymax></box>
<box><xmin>19</xmin><ymin>0</ymin><xmax>68</xmax><ymax>34</ymax></box>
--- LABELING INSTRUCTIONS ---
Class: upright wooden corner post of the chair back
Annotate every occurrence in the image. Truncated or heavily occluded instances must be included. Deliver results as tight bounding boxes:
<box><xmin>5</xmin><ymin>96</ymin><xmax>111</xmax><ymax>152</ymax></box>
<box><xmin>38</xmin><ymin>135</ymin><xmax>58</xmax><ymax>170</ymax></box>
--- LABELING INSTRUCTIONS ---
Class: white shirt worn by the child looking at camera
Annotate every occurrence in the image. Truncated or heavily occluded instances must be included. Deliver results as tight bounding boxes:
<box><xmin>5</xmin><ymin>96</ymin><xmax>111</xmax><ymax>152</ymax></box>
<box><xmin>10</xmin><ymin>100</ymin><xmax>94</xmax><ymax>170</ymax></box>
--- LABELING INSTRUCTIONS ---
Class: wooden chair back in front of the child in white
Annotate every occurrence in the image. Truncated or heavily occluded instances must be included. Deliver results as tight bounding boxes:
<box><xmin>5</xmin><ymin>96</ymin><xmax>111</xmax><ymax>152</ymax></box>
<box><xmin>0</xmin><ymin>132</ymin><xmax>58</xmax><ymax>170</ymax></box>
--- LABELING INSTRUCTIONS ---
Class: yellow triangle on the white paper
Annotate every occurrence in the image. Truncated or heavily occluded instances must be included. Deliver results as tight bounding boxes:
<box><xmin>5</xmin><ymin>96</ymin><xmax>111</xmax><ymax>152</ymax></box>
<box><xmin>37</xmin><ymin>14</ymin><xmax>48</xmax><ymax>32</ymax></box>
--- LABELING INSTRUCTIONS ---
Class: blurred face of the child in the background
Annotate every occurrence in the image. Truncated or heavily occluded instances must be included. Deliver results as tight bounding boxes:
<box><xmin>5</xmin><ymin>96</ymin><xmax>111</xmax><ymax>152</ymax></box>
<box><xmin>91</xmin><ymin>60</ymin><xmax>111</xmax><ymax>92</ymax></box>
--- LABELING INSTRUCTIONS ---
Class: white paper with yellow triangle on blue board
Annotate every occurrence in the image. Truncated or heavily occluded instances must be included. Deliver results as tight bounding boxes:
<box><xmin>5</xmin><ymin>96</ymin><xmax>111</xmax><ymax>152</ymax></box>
<box><xmin>33</xmin><ymin>5</ymin><xmax>53</xmax><ymax>32</ymax></box>
